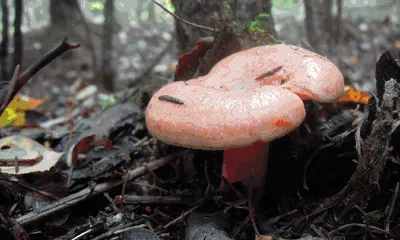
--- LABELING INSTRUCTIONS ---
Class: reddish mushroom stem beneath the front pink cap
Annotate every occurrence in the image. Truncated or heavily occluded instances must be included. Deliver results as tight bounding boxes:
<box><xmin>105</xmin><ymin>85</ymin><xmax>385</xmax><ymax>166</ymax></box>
<box><xmin>221</xmin><ymin>141</ymin><xmax>269</xmax><ymax>205</ymax></box>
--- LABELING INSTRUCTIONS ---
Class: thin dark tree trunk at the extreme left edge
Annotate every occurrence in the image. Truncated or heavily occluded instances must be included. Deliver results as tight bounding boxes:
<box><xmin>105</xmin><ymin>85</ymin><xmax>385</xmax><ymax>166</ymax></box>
<box><xmin>0</xmin><ymin>0</ymin><xmax>10</xmax><ymax>81</ymax></box>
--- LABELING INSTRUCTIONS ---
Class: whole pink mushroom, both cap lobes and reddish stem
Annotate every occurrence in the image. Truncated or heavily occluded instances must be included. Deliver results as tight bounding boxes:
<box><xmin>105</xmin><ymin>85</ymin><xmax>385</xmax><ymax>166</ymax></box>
<box><xmin>146</xmin><ymin>44</ymin><xmax>344</xmax><ymax>202</ymax></box>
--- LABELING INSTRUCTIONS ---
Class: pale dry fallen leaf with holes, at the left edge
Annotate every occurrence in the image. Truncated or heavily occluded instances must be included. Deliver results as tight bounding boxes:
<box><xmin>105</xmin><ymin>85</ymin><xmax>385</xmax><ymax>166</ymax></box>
<box><xmin>0</xmin><ymin>135</ymin><xmax>64</xmax><ymax>174</ymax></box>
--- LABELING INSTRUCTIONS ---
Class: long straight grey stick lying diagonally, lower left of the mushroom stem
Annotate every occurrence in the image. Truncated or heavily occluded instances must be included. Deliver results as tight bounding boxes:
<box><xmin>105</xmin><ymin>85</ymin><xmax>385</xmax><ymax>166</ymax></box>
<box><xmin>17</xmin><ymin>155</ymin><xmax>175</xmax><ymax>225</ymax></box>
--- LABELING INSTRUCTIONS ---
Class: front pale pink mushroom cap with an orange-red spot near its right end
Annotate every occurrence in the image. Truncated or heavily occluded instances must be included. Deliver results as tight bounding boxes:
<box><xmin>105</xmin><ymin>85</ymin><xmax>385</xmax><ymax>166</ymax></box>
<box><xmin>146</xmin><ymin>81</ymin><xmax>305</xmax><ymax>150</ymax></box>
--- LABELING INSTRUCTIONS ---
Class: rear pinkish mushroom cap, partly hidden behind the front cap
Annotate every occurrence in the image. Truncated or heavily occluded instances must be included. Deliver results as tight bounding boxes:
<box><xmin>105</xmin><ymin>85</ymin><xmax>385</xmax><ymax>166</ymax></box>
<box><xmin>197</xmin><ymin>44</ymin><xmax>344</xmax><ymax>102</ymax></box>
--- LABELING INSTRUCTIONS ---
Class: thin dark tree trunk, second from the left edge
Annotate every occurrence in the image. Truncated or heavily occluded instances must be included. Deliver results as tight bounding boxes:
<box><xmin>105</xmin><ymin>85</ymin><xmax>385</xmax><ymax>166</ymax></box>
<box><xmin>11</xmin><ymin>0</ymin><xmax>24</xmax><ymax>69</ymax></box>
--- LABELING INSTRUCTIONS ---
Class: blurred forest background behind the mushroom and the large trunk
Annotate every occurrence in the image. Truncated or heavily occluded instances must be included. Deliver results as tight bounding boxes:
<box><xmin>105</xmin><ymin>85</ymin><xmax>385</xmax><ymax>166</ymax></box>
<box><xmin>0</xmin><ymin>0</ymin><xmax>400</xmax><ymax>97</ymax></box>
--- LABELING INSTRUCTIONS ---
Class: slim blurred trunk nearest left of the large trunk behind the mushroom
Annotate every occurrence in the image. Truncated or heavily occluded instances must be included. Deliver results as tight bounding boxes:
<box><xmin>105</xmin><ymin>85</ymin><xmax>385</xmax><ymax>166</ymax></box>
<box><xmin>102</xmin><ymin>0</ymin><xmax>115</xmax><ymax>92</ymax></box>
